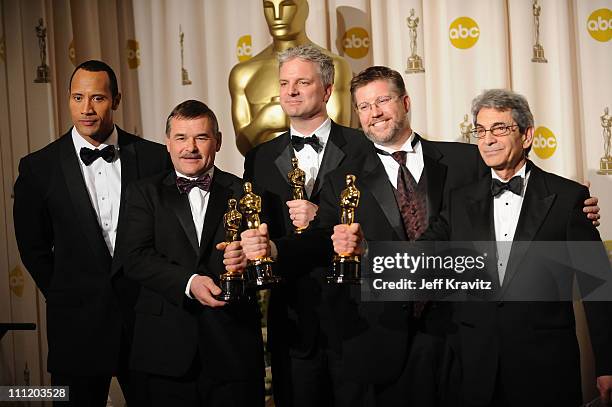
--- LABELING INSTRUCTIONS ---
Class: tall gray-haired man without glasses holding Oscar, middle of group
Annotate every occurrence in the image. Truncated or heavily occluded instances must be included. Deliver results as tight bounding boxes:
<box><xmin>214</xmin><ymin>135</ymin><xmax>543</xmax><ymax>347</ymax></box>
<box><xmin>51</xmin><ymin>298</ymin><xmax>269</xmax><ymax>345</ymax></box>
<box><xmin>244</xmin><ymin>44</ymin><xmax>369</xmax><ymax>407</ymax></box>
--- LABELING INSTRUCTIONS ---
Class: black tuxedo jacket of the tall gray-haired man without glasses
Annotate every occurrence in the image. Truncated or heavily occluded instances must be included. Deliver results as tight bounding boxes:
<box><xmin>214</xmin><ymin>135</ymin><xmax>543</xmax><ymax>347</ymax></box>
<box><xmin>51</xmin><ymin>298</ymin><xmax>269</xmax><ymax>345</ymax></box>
<box><xmin>244</xmin><ymin>121</ymin><xmax>371</xmax><ymax>357</ymax></box>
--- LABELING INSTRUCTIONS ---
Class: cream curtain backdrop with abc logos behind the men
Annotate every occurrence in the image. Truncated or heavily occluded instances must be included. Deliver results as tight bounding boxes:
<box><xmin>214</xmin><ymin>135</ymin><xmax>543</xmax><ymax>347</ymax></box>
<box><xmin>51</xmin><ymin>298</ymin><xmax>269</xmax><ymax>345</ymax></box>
<box><xmin>0</xmin><ymin>0</ymin><xmax>612</xmax><ymax>404</ymax></box>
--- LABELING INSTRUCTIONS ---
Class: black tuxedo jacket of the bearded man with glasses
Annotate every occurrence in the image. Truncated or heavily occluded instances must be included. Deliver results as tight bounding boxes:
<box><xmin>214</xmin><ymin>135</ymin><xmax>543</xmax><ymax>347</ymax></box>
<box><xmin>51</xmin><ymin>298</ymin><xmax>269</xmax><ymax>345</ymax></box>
<box><xmin>277</xmin><ymin>135</ymin><xmax>484</xmax><ymax>383</ymax></box>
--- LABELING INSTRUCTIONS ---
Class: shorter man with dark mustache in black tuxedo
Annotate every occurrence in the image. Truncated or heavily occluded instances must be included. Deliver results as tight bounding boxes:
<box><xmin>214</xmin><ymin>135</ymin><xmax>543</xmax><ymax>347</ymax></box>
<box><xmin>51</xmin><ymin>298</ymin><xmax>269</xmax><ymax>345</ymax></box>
<box><xmin>125</xmin><ymin>100</ymin><xmax>264</xmax><ymax>407</ymax></box>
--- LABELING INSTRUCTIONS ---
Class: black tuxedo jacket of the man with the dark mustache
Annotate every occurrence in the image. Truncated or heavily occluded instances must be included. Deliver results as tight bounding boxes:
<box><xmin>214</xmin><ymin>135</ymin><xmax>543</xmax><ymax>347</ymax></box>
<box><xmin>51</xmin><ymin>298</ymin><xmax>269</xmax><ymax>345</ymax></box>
<box><xmin>126</xmin><ymin>168</ymin><xmax>264</xmax><ymax>380</ymax></box>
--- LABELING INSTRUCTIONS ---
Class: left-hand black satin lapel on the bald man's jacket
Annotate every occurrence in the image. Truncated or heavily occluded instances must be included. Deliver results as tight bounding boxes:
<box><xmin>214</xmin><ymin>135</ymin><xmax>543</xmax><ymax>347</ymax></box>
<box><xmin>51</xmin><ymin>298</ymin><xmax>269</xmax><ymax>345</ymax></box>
<box><xmin>60</xmin><ymin>133</ymin><xmax>112</xmax><ymax>272</ymax></box>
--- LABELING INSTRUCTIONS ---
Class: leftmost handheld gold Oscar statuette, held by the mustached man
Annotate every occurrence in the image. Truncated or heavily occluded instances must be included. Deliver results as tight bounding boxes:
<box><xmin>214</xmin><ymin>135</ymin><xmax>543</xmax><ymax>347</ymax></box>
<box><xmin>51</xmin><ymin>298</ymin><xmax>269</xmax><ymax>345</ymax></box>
<box><xmin>215</xmin><ymin>198</ymin><xmax>245</xmax><ymax>302</ymax></box>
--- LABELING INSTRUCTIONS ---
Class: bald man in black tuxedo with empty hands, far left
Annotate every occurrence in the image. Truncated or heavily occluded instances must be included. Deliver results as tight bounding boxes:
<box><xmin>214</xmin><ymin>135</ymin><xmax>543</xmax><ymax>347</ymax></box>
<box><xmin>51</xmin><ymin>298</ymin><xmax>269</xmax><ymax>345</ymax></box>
<box><xmin>13</xmin><ymin>60</ymin><xmax>170</xmax><ymax>406</ymax></box>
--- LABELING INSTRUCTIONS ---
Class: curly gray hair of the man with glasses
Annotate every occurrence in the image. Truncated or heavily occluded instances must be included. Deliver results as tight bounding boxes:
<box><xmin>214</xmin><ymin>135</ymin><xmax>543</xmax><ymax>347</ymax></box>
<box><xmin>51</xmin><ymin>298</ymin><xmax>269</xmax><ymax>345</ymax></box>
<box><xmin>472</xmin><ymin>89</ymin><xmax>533</xmax><ymax>134</ymax></box>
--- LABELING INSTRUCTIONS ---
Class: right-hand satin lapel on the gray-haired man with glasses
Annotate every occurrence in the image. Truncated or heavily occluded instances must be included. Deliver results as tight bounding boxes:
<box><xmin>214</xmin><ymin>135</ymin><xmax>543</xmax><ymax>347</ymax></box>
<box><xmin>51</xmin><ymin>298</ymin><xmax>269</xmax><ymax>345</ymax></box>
<box><xmin>502</xmin><ymin>166</ymin><xmax>557</xmax><ymax>295</ymax></box>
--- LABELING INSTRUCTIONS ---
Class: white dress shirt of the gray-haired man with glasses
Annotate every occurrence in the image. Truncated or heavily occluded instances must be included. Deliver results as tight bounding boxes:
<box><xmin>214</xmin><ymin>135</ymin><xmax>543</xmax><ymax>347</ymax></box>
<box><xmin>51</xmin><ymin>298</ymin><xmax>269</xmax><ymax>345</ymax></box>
<box><xmin>491</xmin><ymin>165</ymin><xmax>529</xmax><ymax>285</ymax></box>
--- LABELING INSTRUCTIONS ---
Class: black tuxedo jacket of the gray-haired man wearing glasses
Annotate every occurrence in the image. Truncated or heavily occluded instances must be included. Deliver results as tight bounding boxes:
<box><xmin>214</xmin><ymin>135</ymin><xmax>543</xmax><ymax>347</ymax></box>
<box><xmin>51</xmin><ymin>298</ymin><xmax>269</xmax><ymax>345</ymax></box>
<box><xmin>428</xmin><ymin>164</ymin><xmax>612</xmax><ymax>406</ymax></box>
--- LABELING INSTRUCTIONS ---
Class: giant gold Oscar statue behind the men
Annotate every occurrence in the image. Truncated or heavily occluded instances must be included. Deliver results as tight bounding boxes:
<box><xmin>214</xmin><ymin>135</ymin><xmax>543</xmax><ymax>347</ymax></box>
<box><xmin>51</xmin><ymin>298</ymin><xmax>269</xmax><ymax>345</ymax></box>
<box><xmin>229</xmin><ymin>0</ymin><xmax>352</xmax><ymax>155</ymax></box>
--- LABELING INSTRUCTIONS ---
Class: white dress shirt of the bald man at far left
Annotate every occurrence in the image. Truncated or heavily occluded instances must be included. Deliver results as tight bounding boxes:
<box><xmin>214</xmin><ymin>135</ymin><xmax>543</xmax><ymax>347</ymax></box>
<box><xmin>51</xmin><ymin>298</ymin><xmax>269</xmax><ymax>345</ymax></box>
<box><xmin>72</xmin><ymin>127</ymin><xmax>121</xmax><ymax>256</ymax></box>
